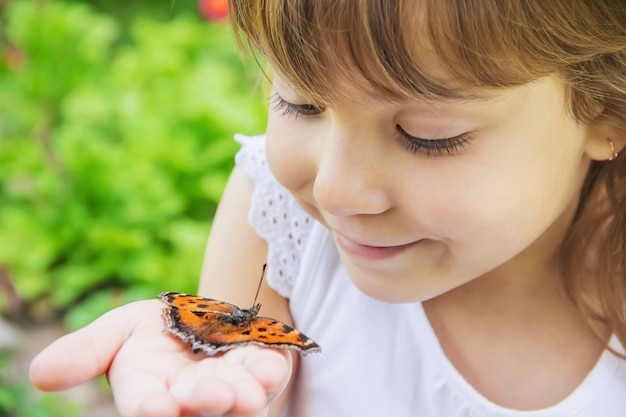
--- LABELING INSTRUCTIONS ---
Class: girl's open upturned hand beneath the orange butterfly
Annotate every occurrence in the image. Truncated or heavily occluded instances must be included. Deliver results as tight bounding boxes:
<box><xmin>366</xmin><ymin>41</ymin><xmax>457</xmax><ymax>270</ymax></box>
<box><xmin>30</xmin><ymin>300</ymin><xmax>292</xmax><ymax>417</ymax></box>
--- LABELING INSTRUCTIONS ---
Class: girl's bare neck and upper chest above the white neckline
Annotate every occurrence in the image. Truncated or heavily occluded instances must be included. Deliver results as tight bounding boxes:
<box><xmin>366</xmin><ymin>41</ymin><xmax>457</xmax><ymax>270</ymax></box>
<box><xmin>424</xmin><ymin>247</ymin><xmax>604</xmax><ymax>410</ymax></box>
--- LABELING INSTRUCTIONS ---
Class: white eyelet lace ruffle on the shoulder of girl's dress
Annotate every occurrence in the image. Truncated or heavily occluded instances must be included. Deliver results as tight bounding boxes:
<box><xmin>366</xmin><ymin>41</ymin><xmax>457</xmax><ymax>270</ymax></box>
<box><xmin>235</xmin><ymin>135</ymin><xmax>313</xmax><ymax>298</ymax></box>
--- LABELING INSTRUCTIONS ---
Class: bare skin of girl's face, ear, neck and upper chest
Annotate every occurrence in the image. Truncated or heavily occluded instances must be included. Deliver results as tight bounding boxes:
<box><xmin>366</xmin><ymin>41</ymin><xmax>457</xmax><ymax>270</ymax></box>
<box><xmin>267</xmin><ymin>72</ymin><xmax>608</xmax><ymax>409</ymax></box>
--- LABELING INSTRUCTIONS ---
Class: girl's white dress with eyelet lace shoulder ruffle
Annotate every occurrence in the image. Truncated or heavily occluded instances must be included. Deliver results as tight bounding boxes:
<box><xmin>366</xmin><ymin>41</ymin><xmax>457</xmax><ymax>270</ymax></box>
<box><xmin>236</xmin><ymin>136</ymin><xmax>626</xmax><ymax>417</ymax></box>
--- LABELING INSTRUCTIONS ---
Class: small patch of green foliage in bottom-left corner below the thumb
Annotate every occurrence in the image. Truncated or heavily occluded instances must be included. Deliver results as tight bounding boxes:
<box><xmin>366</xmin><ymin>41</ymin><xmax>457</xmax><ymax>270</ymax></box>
<box><xmin>0</xmin><ymin>351</ymin><xmax>80</xmax><ymax>417</ymax></box>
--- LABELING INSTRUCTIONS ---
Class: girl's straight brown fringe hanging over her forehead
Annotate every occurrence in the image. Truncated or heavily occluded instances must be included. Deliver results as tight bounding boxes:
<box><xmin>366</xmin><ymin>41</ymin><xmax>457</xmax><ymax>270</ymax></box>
<box><xmin>244</xmin><ymin>0</ymin><xmax>555</xmax><ymax>110</ymax></box>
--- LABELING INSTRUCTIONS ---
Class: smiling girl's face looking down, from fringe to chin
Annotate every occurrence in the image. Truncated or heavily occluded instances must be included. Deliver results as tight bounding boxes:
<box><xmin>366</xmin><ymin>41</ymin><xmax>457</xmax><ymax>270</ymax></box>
<box><xmin>267</xmin><ymin>71</ymin><xmax>589</xmax><ymax>302</ymax></box>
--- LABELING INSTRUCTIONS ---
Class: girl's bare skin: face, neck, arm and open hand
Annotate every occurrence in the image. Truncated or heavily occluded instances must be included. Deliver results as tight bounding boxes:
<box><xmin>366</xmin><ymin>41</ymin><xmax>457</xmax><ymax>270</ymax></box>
<box><xmin>30</xmin><ymin>41</ymin><xmax>626</xmax><ymax>417</ymax></box>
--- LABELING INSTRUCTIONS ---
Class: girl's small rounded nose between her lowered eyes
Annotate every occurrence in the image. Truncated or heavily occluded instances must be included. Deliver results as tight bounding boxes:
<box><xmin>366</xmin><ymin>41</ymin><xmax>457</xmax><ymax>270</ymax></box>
<box><xmin>313</xmin><ymin>122</ymin><xmax>393</xmax><ymax>217</ymax></box>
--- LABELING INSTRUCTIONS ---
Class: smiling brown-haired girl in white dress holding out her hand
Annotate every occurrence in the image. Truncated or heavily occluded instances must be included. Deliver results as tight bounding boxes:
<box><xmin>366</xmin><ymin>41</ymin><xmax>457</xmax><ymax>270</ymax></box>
<box><xmin>31</xmin><ymin>0</ymin><xmax>626</xmax><ymax>417</ymax></box>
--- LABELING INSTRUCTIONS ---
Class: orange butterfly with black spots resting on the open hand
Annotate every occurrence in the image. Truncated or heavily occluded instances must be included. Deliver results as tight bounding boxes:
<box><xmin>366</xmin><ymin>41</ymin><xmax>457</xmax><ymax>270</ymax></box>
<box><xmin>159</xmin><ymin>267</ymin><xmax>321</xmax><ymax>356</ymax></box>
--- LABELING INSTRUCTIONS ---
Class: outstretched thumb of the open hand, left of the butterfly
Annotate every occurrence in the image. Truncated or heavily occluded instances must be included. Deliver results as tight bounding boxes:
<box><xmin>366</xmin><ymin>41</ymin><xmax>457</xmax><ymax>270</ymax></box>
<box><xmin>29</xmin><ymin>300</ymin><xmax>159</xmax><ymax>391</ymax></box>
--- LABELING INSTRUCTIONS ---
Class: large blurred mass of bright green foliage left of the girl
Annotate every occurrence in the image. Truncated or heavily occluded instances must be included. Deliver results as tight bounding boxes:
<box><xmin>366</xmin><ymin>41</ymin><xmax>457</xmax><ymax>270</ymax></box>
<box><xmin>0</xmin><ymin>0</ymin><xmax>266</xmax><ymax>326</ymax></box>
